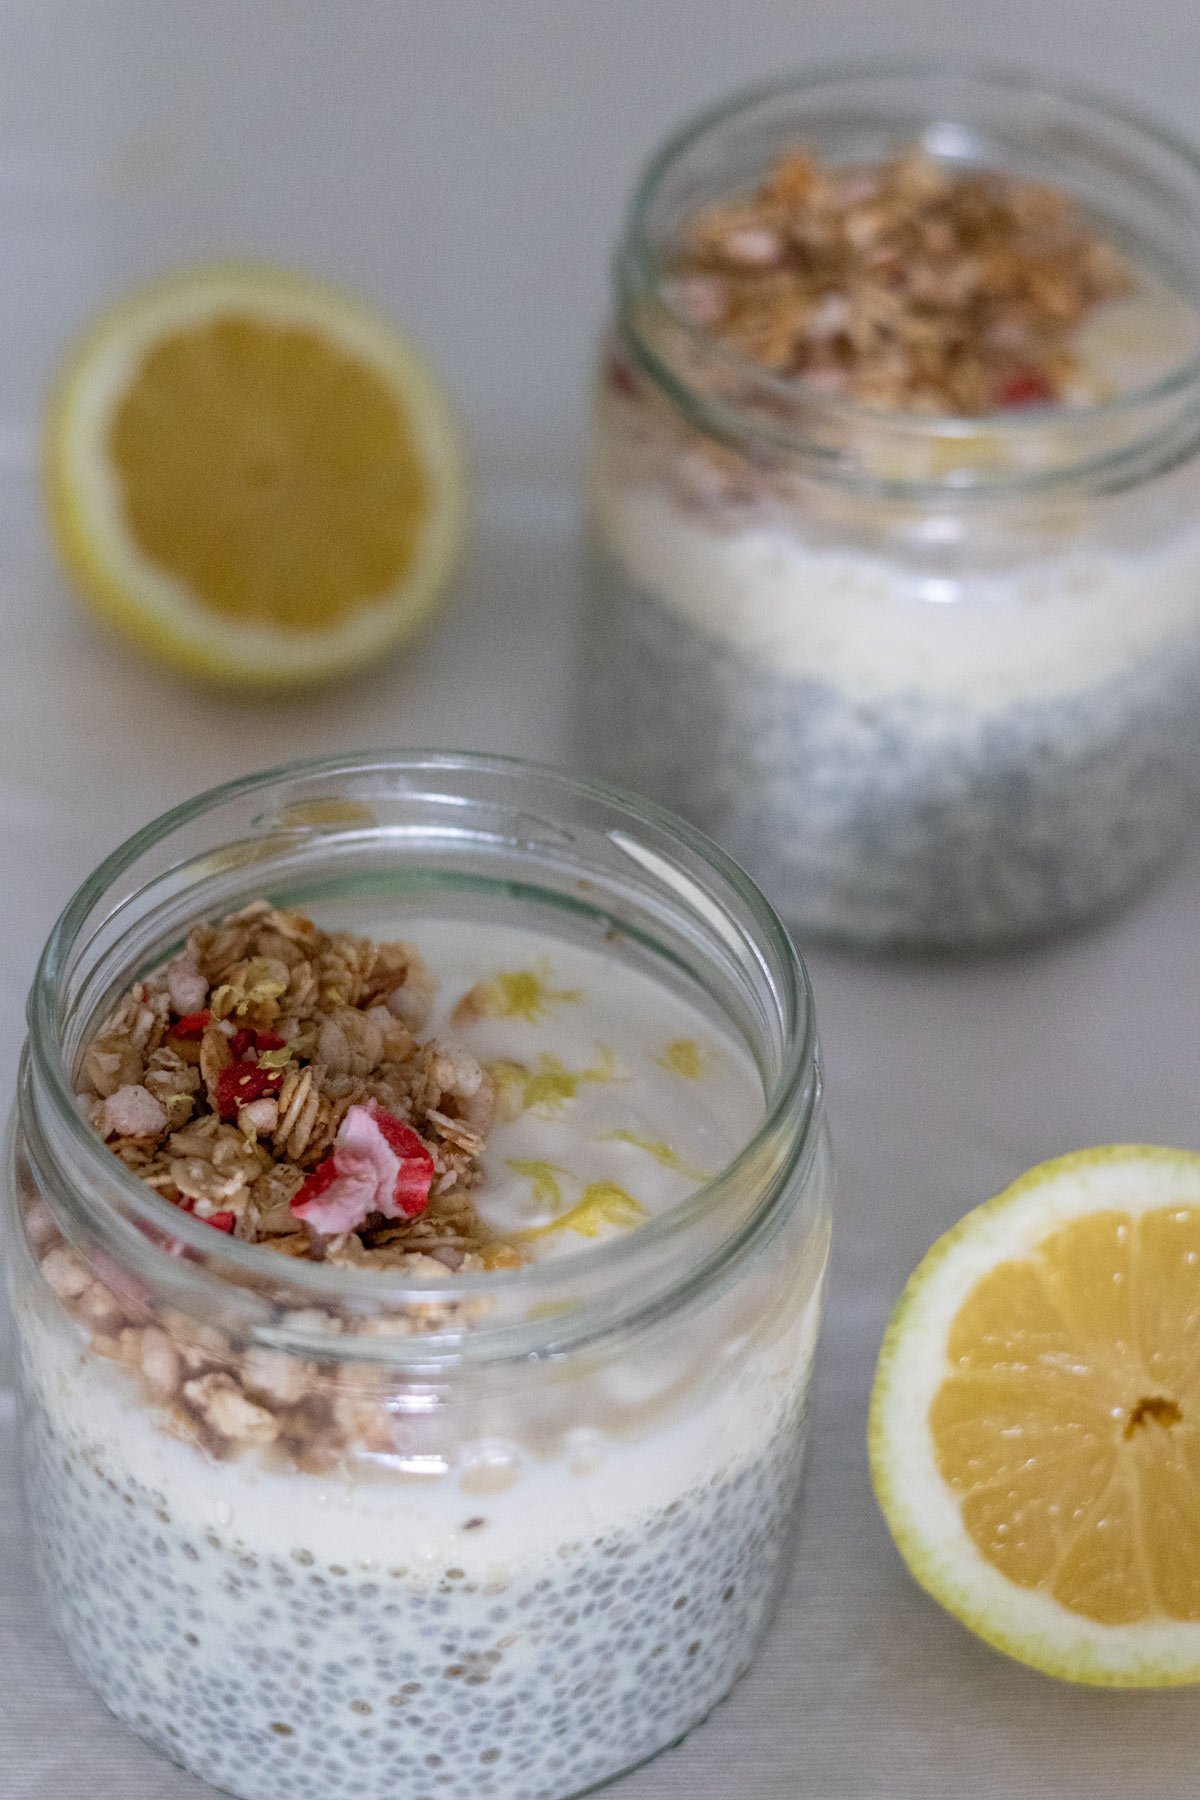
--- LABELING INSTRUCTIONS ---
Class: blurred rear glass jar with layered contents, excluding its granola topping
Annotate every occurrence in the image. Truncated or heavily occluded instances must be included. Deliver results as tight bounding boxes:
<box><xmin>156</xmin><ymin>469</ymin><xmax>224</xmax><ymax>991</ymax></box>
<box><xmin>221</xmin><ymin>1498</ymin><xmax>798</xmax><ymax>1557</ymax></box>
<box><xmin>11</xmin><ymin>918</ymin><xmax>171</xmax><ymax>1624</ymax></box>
<box><xmin>583</xmin><ymin>70</ymin><xmax>1200</xmax><ymax>947</ymax></box>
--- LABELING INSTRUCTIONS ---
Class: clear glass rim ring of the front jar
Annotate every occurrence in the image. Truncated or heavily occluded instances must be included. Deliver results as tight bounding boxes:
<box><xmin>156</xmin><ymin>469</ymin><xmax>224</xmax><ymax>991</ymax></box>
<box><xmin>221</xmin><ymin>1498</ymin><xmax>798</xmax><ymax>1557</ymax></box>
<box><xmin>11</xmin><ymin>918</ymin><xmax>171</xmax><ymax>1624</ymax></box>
<box><xmin>20</xmin><ymin>751</ymin><xmax>819</xmax><ymax>1346</ymax></box>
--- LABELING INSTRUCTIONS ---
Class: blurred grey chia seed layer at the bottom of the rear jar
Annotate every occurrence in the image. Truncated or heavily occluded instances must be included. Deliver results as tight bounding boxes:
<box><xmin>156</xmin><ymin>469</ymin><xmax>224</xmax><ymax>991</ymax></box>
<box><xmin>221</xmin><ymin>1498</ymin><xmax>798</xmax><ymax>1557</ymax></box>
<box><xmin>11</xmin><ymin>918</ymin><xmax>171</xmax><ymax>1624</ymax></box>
<box><xmin>583</xmin><ymin>551</ymin><xmax>1200</xmax><ymax>949</ymax></box>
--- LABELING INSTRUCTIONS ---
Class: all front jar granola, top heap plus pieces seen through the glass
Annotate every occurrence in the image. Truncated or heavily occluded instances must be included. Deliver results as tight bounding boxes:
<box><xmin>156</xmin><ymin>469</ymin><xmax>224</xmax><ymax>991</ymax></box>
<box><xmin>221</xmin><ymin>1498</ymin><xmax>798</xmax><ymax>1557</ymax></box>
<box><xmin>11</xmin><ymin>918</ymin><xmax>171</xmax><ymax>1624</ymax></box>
<box><xmin>18</xmin><ymin>900</ymin><xmax>539</xmax><ymax>1469</ymax></box>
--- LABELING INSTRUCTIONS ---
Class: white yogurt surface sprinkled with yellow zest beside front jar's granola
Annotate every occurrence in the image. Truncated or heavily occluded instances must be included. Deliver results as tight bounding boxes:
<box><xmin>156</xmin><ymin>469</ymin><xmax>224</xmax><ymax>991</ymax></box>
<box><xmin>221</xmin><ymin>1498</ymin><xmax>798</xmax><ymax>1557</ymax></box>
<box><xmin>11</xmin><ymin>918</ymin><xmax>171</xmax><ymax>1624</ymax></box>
<box><xmin>386</xmin><ymin>918</ymin><xmax>763</xmax><ymax>1258</ymax></box>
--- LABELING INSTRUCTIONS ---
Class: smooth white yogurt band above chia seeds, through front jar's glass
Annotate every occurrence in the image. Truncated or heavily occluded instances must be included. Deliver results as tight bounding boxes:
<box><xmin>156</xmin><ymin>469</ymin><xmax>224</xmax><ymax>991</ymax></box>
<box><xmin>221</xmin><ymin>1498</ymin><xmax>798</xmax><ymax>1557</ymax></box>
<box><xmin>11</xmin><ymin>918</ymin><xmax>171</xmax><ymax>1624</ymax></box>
<box><xmin>22</xmin><ymin>1260</ymin><xmax>822</xmax><ymax>1584</ymax></box>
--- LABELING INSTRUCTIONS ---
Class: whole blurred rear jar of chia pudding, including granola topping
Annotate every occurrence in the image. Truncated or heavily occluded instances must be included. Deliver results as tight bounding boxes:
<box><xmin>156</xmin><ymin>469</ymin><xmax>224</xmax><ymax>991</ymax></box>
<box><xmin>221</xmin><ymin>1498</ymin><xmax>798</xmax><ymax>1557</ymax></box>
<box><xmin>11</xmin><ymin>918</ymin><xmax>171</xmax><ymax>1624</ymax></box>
<box><xmin>583</xmin><ymin>65</ymin><xmax>1200</xmax><ymax>947</ymax></box>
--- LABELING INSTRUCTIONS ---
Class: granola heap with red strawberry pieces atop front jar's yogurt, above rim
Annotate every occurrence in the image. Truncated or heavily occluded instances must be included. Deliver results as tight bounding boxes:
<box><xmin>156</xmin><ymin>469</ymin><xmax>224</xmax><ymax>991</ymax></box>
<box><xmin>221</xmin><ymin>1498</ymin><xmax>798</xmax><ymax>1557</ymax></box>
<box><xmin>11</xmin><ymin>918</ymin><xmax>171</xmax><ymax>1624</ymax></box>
<box><xmin>81</xmin><ymin>900</ymin><xmax>520</xmax><ymax>1271</ymax></box>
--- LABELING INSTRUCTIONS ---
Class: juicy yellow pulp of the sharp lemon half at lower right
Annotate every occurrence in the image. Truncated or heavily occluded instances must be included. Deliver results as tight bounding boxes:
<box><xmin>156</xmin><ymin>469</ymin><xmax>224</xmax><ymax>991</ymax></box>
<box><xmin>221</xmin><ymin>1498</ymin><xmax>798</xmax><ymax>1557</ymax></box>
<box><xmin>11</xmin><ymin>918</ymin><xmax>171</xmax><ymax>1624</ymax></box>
<box><xmin>930</xmin><ymin>1206</ymin><xmax>1200</xmax><ymax>1624</ymax></box>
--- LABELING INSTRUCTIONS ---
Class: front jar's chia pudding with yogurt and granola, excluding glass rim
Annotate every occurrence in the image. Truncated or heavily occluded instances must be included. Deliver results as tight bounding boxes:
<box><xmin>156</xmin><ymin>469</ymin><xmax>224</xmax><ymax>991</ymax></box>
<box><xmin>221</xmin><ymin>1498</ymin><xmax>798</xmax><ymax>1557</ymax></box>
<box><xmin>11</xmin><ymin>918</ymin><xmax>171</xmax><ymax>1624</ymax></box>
<box><xmin>11</xmin><ymin>752</ymin><xmax>828</xmax><ymax>1800</ymax></box>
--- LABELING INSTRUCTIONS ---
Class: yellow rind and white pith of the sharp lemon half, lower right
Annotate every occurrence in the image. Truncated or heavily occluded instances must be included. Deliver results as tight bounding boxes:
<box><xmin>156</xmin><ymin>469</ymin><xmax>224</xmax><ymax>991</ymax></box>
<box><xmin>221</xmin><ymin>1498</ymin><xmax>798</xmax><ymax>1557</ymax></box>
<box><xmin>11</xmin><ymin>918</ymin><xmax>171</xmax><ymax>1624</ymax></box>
<box><xmin>867</xmin><ymin>1145</ymin><xmax>1200</xmax><ymax>1688</ymax></box>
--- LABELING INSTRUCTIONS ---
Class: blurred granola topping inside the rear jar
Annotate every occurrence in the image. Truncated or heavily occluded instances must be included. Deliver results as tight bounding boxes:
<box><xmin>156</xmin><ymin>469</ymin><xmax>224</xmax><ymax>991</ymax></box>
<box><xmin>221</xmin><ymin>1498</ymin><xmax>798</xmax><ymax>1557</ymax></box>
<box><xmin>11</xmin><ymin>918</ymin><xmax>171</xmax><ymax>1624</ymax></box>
<box><xmin>669</xmin><ymin>149</ymin><xmax>1133</xmax><ymax>416</ymax></box>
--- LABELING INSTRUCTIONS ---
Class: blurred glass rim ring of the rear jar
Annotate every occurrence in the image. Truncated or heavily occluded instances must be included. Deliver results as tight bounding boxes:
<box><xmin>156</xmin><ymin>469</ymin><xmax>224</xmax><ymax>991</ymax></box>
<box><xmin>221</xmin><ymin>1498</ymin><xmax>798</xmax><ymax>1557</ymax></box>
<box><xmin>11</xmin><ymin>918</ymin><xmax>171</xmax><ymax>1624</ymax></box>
<box><xmin>613</xmin><ymin>59</ymin><xmax>1200</xmax><ymax>491</ymax></box>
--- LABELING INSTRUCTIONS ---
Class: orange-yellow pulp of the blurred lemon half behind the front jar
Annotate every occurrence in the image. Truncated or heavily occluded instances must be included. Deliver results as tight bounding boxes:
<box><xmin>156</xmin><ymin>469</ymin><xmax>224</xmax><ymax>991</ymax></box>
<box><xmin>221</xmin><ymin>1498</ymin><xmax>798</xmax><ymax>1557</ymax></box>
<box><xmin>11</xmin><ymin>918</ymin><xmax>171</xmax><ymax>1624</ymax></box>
<box><xmin>110</xmin><ymin>313</ymin><xmax>428</xmax><ymax>632</ymax></box>
